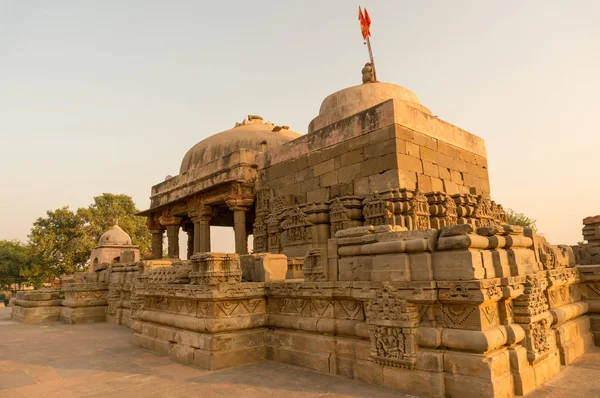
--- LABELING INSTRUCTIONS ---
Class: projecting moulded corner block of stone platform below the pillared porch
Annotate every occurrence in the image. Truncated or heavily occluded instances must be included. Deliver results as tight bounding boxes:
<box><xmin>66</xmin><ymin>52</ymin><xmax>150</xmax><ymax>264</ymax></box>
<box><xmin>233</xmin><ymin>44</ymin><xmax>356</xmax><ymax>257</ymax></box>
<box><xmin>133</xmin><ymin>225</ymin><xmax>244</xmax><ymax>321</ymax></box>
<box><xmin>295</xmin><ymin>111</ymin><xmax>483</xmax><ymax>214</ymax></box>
<box><xmin>132</xmin><ymin>283</ymin><xmax>267</xmax><ymax>370</ymax></box>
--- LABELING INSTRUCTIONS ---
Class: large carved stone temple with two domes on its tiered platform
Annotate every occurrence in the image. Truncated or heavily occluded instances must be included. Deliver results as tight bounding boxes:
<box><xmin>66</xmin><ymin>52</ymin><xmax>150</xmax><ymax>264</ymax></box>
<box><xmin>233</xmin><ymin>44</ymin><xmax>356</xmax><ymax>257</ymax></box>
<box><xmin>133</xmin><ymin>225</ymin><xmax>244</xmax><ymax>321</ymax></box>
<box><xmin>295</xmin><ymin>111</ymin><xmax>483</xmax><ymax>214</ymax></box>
<box><xmin>13</xmin><ymin>66</ymin><xmax>600</xmax><ymax>397</ymax></box>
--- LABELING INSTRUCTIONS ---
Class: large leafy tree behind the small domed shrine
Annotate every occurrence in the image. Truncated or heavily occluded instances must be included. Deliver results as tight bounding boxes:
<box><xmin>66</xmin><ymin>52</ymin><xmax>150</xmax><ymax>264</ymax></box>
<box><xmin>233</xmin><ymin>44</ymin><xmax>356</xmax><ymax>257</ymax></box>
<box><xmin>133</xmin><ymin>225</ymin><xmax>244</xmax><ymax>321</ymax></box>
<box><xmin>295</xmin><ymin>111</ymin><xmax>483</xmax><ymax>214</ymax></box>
<box><xmin>21</xmin><ymin>193</ymin><xmax>150</xmax><ymax>284</ymax></box>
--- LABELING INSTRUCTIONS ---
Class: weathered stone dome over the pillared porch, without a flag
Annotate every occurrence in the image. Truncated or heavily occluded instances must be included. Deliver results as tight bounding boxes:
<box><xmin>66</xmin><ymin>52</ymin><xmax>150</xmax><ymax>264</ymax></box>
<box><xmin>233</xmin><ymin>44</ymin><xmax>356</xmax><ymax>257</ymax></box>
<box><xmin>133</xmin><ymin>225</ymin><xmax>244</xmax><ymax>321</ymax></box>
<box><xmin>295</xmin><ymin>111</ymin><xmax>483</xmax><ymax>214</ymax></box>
<box><xmin>179</xmin><ymin>115</ymin><xmax>300</xmax><ymax>174</ymax></box>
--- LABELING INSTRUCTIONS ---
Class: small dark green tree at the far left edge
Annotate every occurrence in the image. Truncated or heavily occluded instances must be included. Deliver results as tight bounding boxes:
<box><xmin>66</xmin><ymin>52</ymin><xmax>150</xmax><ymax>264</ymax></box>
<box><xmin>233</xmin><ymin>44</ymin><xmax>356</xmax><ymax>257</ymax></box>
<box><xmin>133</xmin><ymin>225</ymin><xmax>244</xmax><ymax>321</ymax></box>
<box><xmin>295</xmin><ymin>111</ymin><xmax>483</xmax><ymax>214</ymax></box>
<box><xmin>0</xmin><ymin>240</ymin><xmax>32</xmax><ymax>290</ymax></box>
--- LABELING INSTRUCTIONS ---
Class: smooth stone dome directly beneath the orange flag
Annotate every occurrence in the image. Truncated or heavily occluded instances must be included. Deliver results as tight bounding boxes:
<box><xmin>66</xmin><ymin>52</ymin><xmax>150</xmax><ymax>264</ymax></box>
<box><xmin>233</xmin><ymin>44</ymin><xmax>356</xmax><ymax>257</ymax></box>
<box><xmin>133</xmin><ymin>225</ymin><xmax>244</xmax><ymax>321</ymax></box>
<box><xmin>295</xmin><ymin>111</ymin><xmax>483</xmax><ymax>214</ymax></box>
<box><xmin>309</xmin><ymin>82</ymin><xmax>431</xmax><ymax>133</ymax></box>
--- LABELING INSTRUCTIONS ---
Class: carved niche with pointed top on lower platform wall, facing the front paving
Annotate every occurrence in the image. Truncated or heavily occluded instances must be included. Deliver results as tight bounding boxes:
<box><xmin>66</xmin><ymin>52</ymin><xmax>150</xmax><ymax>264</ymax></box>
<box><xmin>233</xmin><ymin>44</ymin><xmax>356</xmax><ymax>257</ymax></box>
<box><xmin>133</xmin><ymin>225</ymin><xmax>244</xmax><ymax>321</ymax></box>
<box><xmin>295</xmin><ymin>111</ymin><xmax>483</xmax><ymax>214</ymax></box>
<box><xmin>366</xmin><ymin>283</ymin><xmax>419</xmax><ymax>369</ymax></box>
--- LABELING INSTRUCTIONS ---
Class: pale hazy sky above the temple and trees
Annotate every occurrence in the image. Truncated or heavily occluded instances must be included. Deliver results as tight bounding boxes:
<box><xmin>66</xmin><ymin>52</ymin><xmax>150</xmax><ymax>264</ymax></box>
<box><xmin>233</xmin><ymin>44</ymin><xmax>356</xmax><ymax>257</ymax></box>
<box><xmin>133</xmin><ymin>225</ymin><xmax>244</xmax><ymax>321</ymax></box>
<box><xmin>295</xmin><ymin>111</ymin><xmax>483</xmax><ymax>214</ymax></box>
<box><xmin>0</xmin><ymin>0</ymin><xmax>600</xmax><ymax>253</ymax></box>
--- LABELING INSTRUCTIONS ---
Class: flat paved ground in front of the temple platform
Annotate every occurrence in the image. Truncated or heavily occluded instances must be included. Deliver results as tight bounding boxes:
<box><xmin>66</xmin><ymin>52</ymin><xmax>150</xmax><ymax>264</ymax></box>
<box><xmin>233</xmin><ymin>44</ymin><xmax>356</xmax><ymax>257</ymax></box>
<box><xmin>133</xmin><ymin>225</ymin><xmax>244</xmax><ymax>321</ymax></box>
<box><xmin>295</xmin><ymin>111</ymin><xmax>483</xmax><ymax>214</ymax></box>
<box><xmin>0</xmin><ymin>308</ymin><xmax>600</xmax><ymax>398</ymax></box>
